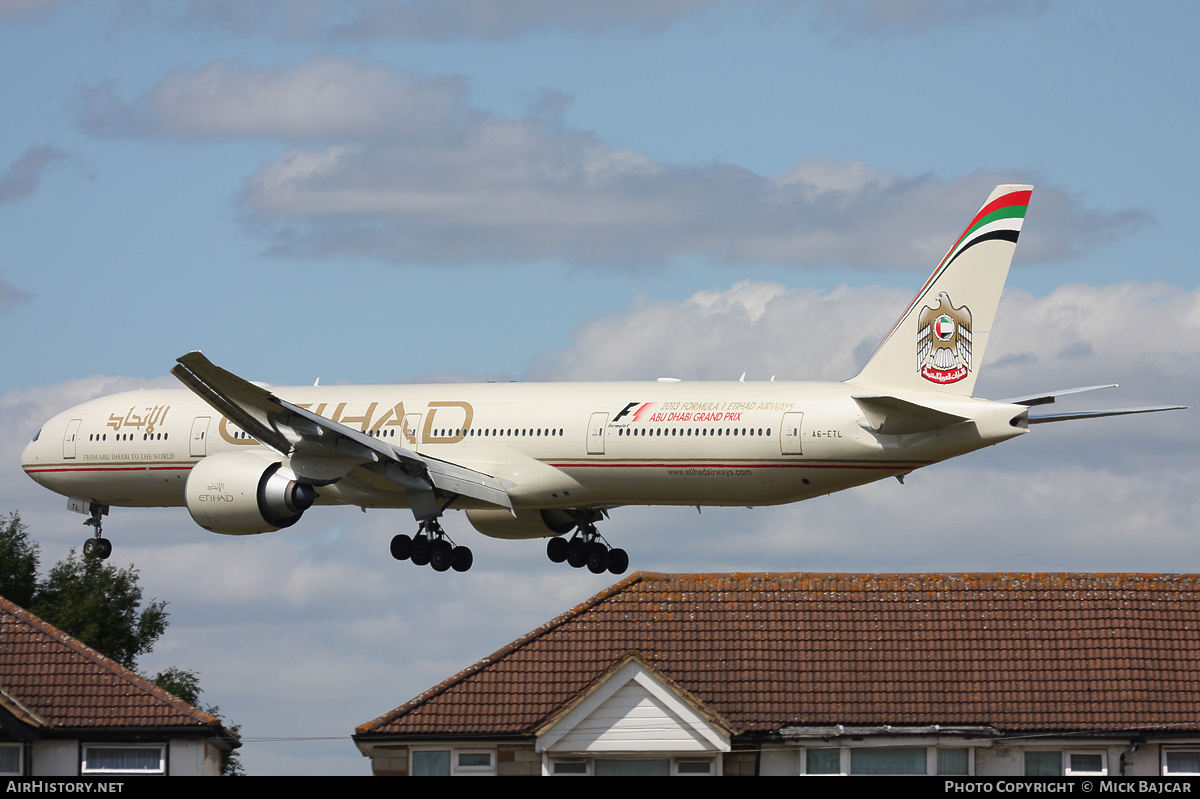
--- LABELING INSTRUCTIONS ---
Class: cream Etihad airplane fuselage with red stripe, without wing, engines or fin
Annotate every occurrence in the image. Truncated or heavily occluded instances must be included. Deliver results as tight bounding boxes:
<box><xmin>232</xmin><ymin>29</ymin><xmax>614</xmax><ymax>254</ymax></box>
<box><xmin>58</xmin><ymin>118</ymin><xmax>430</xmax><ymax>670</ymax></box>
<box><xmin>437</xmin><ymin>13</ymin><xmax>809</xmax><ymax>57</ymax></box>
<box><xmin>22</xmin><ymin>382</ymin><xmax>1027</xmax><ymax>509</ymax></box>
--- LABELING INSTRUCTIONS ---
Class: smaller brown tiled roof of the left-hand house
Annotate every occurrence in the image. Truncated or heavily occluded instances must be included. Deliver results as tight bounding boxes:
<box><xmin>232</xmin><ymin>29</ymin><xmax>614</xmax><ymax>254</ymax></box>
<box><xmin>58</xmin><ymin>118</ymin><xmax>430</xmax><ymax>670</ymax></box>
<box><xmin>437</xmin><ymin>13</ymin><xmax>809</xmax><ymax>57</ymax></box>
<box><xmin>0</xmin><ymin>597</ymin><xmax>234</xmax><ymax>740</ymax></box>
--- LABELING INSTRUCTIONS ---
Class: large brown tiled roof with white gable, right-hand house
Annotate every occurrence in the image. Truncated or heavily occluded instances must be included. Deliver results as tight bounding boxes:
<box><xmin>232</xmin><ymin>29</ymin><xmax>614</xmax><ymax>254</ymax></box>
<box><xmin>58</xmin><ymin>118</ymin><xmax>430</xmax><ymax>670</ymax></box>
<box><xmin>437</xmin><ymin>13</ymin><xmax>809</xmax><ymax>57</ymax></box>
<box><xmin>358</xmin><ymin>572</ymin><xmax>1200</xmax><ymax>737</ymax></box>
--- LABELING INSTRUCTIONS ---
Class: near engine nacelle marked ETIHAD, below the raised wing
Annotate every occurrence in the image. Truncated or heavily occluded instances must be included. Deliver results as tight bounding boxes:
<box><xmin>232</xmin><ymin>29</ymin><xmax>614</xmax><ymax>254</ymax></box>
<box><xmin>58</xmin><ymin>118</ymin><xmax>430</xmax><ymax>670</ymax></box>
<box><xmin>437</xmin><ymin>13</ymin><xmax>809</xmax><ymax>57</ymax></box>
<box><xmin>185</xmin><ymin>452</ymin><xmax>317</xmax><ymax>535</ymax></box>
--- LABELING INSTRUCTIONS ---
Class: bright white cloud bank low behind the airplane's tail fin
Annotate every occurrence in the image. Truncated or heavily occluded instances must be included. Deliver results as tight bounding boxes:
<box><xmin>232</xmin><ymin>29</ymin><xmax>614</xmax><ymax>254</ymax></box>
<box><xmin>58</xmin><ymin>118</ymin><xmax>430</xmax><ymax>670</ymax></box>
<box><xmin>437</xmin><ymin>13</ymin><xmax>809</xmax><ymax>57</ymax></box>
<box><xmin>526</xmin><ymin>281</ymin><xmax>1200</xmax><ymax>402</ymax></box>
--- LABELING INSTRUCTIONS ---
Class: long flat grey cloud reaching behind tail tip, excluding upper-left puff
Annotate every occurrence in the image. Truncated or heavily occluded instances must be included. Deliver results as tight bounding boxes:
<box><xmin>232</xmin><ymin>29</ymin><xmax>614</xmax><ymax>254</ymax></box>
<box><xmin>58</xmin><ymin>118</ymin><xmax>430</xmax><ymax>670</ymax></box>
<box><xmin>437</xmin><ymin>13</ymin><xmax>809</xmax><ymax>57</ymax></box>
<box><xmin>241</xmin><ymin>143</ymin><xmax>1145</xmax><ymax>269</ymax></box>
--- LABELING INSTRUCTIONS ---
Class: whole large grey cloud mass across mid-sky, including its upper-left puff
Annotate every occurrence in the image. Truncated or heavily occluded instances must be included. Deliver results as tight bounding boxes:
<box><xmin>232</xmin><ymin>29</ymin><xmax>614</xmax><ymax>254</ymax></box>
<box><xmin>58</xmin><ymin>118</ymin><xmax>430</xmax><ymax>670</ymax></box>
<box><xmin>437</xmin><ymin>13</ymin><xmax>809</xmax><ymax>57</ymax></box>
<box><xmin>79</xmin><ymin>58</ymin><xmax>1146</xmax><ymax>269</ymax></box>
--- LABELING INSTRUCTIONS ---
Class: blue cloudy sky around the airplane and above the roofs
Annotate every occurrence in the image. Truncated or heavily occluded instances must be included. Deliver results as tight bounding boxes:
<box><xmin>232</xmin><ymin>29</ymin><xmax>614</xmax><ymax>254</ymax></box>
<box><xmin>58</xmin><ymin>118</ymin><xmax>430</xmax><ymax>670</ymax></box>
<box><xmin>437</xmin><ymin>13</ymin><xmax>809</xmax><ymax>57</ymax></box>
<box><xmin>0</xmin><ymin>0</ymin><xmax>1200</xmax><ymax>774</ymax></box>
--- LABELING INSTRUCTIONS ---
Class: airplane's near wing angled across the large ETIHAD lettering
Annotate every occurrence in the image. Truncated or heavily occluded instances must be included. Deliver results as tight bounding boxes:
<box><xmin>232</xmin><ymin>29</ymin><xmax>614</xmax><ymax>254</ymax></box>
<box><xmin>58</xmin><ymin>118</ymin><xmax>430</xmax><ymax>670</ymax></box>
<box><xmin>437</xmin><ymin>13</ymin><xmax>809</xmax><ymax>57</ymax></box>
<box><xmin>170</xmin><ymin>352</ymin><xmax>512</xmax><ymax>521</ymax></box>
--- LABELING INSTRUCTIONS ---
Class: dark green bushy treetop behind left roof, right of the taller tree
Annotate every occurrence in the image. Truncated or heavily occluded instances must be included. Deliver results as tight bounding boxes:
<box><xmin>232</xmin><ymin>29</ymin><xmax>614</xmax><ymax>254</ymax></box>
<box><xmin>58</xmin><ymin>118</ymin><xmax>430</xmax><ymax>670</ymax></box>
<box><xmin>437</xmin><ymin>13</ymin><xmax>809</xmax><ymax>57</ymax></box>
<box><xmin>29</xmin><ymin>549</ymin><xmax>168</xmax><ymax>668</ymax></box>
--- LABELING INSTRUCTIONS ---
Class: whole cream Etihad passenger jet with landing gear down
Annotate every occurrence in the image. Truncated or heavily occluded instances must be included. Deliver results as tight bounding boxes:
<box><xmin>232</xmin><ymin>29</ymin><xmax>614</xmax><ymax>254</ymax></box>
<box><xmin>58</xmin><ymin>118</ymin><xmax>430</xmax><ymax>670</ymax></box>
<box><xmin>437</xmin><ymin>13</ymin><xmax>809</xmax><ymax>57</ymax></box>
<box><xmin>22</xmin><ymin>185</ymin><xmax>1183</xmax><ymax>575</ymax></box>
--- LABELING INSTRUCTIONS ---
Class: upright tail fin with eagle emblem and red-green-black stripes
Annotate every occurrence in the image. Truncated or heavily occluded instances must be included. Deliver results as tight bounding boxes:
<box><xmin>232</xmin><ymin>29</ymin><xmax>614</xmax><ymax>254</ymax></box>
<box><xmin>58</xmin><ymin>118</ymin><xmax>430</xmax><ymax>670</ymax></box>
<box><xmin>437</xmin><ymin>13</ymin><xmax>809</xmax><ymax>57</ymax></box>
<box><xmin>848</xmin><ymin>184</ymin><xmax>1033</xmax><ymax>396</ymax></box>
